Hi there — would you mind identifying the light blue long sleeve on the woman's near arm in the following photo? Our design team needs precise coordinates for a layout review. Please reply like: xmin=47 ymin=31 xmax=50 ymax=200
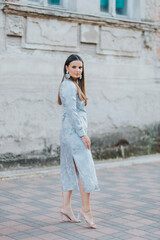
xmin=61 ymin=81 xmax=86 ymax=137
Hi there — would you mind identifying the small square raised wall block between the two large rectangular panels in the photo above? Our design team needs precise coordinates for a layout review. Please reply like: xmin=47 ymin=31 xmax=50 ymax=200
xmin=81 ymin=24 xmax=99 ymax=44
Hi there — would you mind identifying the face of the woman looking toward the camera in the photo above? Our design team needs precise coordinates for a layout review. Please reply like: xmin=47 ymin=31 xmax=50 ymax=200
xmin=66 ymin=60 xmax=83 ymax=80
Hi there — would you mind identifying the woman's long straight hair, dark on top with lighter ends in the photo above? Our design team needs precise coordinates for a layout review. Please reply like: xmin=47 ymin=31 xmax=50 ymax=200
xmin=58 ymin=54 xmax=88 ymax=106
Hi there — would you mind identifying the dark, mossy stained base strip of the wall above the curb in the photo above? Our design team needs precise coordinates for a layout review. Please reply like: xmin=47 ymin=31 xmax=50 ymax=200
xmin=0 ymin=124 xmax=160 ymax=171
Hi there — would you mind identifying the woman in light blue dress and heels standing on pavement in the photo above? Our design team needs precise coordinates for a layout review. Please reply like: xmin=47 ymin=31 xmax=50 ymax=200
xmin=58 ymin=55 xmax=100 ymax=228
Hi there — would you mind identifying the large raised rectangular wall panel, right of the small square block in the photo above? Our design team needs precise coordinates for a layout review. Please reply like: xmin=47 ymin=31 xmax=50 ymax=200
xmin=99 ymin=26 xmax=141 ymax=56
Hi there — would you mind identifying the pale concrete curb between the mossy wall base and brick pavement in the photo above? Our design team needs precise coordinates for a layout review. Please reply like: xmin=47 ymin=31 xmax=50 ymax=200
xmin=0 ymin=154 xmax=160 ymax=181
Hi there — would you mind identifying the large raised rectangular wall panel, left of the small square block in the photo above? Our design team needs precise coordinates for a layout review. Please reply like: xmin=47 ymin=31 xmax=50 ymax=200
xmin=26 ymin=17 xmax=78 ymax=48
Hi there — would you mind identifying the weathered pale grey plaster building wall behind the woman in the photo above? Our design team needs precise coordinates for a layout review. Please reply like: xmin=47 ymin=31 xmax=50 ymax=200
xmin=0 ymin=0 xmax=160 ymax=165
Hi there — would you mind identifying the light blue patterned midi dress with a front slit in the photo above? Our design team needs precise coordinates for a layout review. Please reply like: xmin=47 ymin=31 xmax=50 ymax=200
xmin=60 ymin=78 xmax=100 ymax=193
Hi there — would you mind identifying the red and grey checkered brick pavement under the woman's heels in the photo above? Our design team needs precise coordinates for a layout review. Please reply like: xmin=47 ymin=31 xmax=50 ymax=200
xmin=0 ymin=163 xmax=160 ymax=240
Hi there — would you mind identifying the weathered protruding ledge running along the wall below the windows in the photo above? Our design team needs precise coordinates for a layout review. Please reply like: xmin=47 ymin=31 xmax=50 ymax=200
xmin=0 ymin=2 xmax=160 ymax=32
